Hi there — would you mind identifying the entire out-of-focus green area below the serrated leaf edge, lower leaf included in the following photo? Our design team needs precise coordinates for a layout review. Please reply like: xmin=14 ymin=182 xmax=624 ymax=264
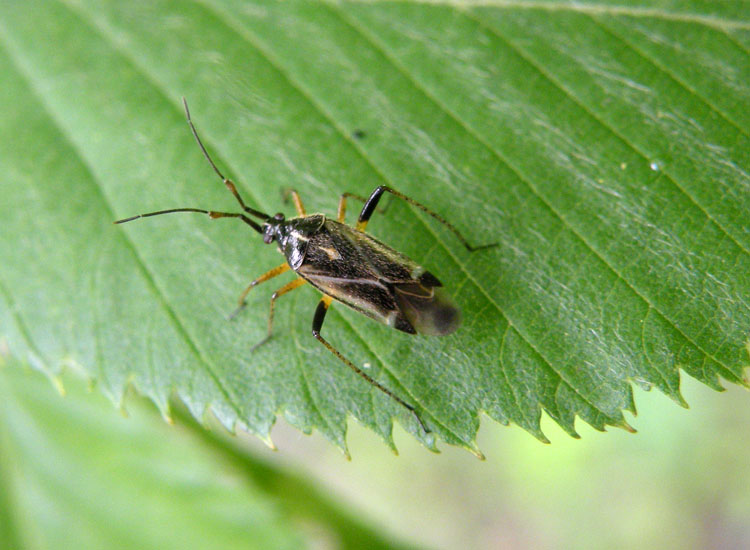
xmin=0 ymin=364 xmax=750 ymax=549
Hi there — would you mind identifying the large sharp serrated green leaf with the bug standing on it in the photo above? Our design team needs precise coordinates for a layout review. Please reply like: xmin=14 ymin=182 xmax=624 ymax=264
xmin=0 ymin=0 xmax=750 ymax=453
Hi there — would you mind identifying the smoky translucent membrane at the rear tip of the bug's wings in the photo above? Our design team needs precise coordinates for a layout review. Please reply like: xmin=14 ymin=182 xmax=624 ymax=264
xmin=393 ymin=282 xmax=461 ymax=336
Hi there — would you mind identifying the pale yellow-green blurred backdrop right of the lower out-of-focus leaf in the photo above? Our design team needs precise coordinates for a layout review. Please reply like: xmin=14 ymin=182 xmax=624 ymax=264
xmin=296 ymin=380 xmax=750 ymax=549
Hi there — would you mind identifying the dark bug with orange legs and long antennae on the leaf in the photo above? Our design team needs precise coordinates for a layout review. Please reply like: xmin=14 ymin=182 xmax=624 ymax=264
xmin=114 ymin=98 xmax=497 ymax=433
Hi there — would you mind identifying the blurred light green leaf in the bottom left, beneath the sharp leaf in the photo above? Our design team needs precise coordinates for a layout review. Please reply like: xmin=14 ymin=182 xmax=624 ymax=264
xmin=0 ymin=367 xmax=302 ymax=549
